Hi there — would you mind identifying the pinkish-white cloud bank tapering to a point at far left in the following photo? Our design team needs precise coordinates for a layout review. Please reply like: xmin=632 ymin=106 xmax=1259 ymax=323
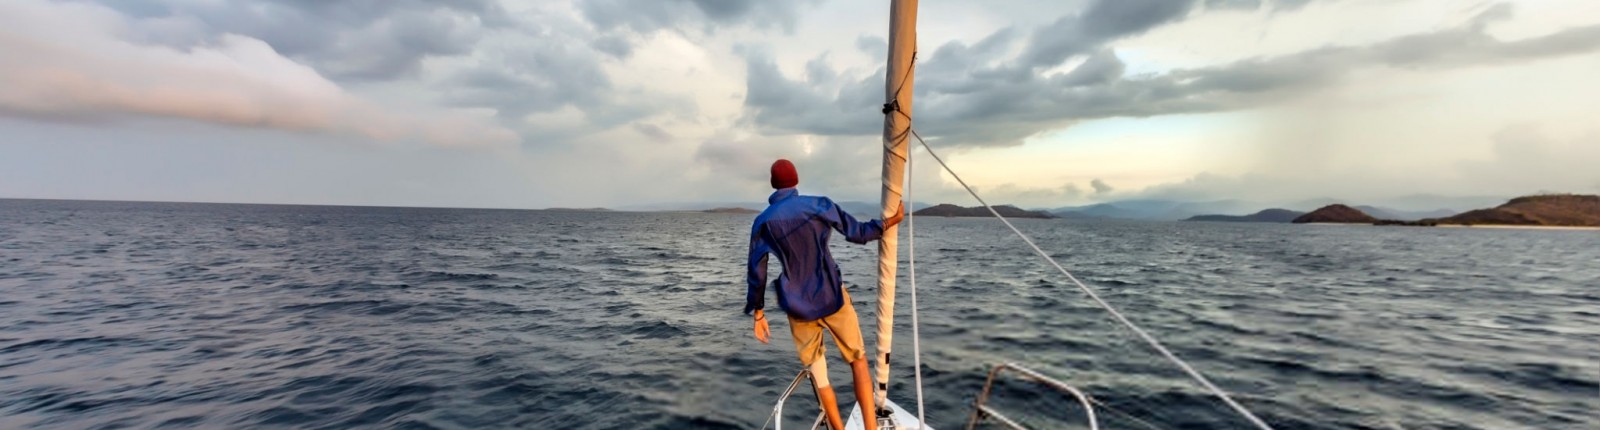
xmin=0 ymin=0 xmax=518 ymax=145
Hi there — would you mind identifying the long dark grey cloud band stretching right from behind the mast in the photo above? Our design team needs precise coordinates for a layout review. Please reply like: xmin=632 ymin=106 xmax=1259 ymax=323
xmin=732 ymin=6 xmax=1600 ymax=145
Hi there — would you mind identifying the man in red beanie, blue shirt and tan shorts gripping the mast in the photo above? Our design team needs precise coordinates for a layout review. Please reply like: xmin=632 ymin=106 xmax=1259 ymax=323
xmin=744 ymin=160 xmax=904 ymax=430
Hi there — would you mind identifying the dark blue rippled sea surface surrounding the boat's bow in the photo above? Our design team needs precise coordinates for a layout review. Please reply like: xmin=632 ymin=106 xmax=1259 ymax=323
xmin=0 ymin=200 xmax=1600 ymax=428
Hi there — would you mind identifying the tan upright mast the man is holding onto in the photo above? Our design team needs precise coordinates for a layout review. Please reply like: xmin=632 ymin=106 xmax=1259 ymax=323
xmin=862 ymin=0 xmax=917 ymax=406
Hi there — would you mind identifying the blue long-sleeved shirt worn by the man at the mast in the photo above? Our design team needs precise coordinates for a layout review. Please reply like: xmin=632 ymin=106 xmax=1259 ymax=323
xmin=744 ymin=189 xmax=883 ymax=321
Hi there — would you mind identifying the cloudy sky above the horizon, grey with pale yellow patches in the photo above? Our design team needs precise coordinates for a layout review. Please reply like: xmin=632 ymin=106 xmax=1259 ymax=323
xmin=0 ymin=0 xmax=1600 ymax=209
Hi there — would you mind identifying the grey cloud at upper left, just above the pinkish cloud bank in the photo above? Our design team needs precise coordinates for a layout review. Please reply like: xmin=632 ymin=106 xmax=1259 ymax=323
xmin=102 ymin=0 xmax=512 ymax=80
